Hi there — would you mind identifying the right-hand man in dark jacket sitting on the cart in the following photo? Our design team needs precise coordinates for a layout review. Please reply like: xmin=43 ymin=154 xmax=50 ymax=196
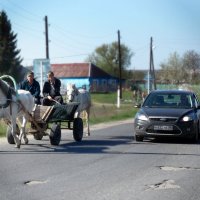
xmin=42 ymin=71 xmax=63 ymax=106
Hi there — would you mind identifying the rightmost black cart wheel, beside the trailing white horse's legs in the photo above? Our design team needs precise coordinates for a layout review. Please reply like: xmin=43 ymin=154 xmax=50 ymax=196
xmin=73 ymin=118 xmax=83 ymax=142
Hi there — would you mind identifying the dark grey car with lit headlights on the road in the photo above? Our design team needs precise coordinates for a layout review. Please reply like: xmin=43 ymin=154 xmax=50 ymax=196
xmin=134 ymin=90 xmax=200 ymax=141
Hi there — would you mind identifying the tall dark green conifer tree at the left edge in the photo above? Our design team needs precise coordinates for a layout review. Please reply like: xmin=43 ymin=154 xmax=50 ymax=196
xmin=0 ymin=11 xmax=22 ymax=81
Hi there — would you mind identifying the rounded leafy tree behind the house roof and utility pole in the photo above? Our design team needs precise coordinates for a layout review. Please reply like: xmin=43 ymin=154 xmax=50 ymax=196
xmin=86 ymin=42 xmax=133 ymax=78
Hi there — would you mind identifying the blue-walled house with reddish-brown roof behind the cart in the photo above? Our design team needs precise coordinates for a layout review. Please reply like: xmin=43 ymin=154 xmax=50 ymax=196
xmin=51 ymin=63 xmax=118 ymax=92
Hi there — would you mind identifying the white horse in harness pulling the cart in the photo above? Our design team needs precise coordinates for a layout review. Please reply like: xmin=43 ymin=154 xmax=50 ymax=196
xmin=0 ymin=79 xmax=34 ymax=148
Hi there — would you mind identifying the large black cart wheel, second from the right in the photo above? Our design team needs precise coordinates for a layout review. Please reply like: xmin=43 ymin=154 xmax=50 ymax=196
xmin=49 ymin=123 xmax=61 ymax=145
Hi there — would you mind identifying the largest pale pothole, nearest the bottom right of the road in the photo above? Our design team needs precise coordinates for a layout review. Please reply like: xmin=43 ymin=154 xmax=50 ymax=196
xmin=146 ymin=180 xmax=180 ymax=191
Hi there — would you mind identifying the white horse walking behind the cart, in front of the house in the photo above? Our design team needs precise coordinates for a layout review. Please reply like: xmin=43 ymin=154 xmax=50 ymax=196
xmin=67 ymin=84 xmax=91 ymax=136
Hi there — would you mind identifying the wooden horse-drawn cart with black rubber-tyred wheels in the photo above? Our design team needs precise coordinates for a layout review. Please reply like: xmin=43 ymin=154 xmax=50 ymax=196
xmin=7 ymin=102 xmax=83 ymax=145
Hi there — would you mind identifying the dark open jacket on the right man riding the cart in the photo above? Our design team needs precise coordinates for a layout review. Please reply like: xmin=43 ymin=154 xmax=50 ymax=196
xmin=42 ymin=77 xmax=61 ymax=98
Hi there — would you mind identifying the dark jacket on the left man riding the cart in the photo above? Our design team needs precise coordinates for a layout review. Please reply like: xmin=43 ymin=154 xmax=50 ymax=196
xmin=19 ymin=79 xmax=40 ymax=98
